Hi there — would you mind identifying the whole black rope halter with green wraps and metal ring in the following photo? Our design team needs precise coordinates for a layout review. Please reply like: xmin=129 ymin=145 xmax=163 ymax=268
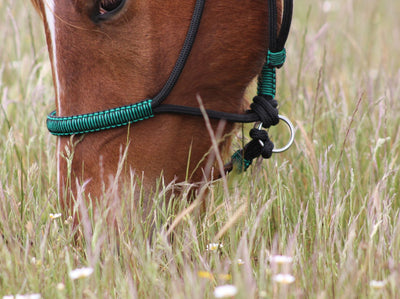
xmin=47 ymin=0 xmax=294 ymax=171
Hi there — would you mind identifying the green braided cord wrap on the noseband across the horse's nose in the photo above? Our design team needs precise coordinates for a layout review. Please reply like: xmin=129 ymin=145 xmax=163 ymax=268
xmin=47 ymin=100 xmax=154 ymax=136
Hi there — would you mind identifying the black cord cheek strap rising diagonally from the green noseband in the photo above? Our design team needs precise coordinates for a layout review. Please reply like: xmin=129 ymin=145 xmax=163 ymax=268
xmin=151 ymin=0 xmax=205 ymax=108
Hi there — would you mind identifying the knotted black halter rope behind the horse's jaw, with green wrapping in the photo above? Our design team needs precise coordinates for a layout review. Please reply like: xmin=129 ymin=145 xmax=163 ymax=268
xmin=225 ymin=0 xmax=293 ymax=172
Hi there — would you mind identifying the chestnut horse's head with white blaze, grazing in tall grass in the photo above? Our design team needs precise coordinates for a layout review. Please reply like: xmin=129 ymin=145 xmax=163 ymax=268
xmin=31 ymin=0 xmax=283 ymax=218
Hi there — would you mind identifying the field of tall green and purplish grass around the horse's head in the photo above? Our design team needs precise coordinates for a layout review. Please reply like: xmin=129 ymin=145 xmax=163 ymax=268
xmin=0 ymin=0 xmax=400 ymax=298
